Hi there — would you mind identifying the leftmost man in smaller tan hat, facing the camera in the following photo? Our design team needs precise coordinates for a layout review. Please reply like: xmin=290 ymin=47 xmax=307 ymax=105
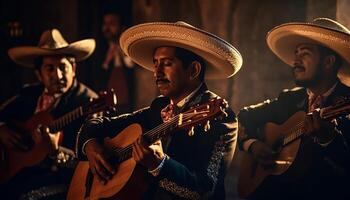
xmin=0 ymin=29 xmax=97 ymax=199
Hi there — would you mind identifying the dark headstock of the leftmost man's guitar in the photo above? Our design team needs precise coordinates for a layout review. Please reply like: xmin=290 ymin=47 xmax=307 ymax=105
xmin=84 ymin=89 xmax=117 ymax=115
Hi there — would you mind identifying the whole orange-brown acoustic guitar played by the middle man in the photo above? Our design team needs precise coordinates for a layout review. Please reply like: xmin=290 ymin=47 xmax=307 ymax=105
xmin=67 ymin=99 xmax=227 ymax=200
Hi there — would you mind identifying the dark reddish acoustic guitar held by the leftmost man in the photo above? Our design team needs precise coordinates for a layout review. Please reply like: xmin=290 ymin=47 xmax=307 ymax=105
xmin=0 ymin=90 xmax=117 ymax=183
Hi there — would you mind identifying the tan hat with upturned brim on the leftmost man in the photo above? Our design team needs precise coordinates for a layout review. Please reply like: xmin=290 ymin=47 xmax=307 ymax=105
xmin=8 ymin=29 xmax=96 ymax=68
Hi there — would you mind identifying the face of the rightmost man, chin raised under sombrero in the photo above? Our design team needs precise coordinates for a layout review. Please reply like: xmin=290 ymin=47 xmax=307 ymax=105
xmin=292 ymin=44 xmax=323 ymax=87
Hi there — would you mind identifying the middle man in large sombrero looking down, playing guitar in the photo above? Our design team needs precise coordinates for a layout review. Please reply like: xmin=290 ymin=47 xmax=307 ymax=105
xmin=78 ymin=22 xmax=242 ymax=199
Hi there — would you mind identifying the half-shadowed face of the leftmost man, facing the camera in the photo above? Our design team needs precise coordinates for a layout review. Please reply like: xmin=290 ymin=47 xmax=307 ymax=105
xmin=37 ymin=55 xmax=75 ymax=94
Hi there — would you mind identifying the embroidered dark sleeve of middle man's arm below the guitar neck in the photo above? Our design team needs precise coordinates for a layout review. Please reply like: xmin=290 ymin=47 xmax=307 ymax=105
xmin=157 ymin=106 xmax=237 ymax=199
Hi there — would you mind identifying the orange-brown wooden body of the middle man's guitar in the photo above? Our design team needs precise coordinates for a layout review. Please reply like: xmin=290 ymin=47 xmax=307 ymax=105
xmin=67 ymin=124 xmax=147 ymax=200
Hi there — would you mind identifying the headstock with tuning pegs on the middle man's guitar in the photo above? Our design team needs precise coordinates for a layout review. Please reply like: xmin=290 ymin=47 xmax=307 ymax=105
xmin=178 ymin=98 xmax=228 ymax=131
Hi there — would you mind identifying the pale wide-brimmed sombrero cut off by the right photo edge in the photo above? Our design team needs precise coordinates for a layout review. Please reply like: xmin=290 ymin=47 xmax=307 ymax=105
xmin=266 ymin=18 xmax=350 ymax=83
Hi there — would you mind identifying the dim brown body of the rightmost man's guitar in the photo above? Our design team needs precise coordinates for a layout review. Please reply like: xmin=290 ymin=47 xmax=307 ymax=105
xmin=238 ymin=111 xmax=312 ymax=198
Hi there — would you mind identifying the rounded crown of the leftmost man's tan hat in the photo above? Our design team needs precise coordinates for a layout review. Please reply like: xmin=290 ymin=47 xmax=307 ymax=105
xmin=38 ymin=29 xmax=68 ymax=50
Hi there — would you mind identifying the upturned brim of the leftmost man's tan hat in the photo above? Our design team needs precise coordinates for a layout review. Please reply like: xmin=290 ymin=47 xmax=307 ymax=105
xmin=8 ymin=39 xmax=96 ymax=68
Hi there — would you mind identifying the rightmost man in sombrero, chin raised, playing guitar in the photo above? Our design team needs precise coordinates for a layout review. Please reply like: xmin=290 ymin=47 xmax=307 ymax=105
xmin=238 ymin=18 xmax=350 ymax=199
